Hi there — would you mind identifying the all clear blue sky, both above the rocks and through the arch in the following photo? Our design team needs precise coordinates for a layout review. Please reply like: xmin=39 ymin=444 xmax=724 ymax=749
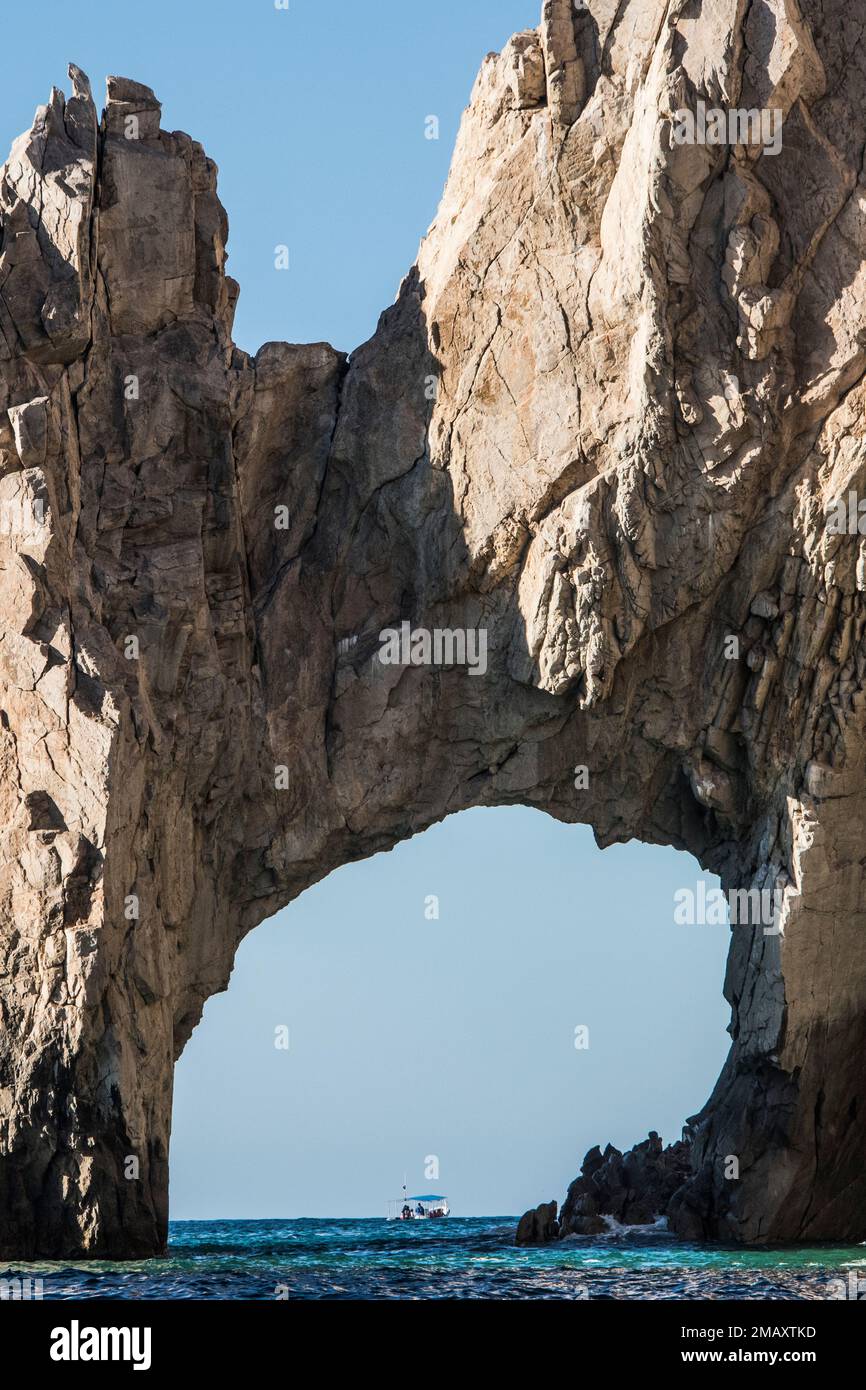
xmin=0 ymin=0 xmax=728 ymax=1218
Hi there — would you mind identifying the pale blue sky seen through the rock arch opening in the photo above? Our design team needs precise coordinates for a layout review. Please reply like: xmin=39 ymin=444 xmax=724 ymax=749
xmin=171 ymin=808 xmax=728 ymax=1219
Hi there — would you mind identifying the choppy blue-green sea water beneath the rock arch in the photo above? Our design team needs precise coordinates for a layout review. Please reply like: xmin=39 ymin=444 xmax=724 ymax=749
xmin=0 ymin=1216 xmax=866 ymax=1300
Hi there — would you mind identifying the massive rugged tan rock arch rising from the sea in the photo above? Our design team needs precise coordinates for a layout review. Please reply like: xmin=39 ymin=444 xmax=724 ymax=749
xmin=0 ymin=0 xmax=866 ymax=1258
